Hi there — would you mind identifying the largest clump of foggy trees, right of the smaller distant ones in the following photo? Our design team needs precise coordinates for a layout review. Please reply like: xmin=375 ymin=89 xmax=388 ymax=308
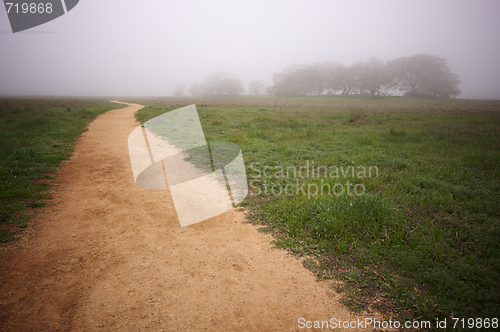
xmin=266 ymin=54 xmax=460 ymax=98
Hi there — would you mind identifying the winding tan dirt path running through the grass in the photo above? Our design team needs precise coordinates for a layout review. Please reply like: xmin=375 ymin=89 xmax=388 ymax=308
xmin=0 ymin=104 xmax=376 ymax=331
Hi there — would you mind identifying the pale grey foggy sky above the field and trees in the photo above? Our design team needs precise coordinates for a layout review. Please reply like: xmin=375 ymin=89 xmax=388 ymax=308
xmin=0 ymin=0 xmax=500 ymax=99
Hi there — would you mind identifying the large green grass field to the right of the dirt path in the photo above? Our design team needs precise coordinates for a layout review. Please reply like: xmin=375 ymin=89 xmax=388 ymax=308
xmin=134 ymin=97 xmax=500 ymax=319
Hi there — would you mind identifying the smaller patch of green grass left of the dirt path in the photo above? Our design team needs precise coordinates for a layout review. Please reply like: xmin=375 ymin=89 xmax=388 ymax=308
xmin=0 ymin=98 xmax=126 ymax=244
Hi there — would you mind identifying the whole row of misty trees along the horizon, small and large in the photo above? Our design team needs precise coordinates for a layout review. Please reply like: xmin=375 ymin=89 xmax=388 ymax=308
xmin=174 ymin=54 xmax=461 ymax=98
